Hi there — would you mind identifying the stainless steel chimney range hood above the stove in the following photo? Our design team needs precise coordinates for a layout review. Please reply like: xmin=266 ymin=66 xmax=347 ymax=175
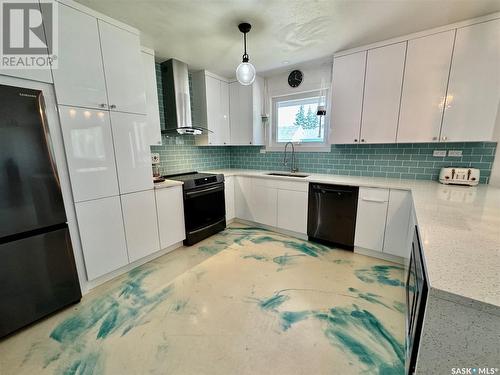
xmin=161 ymin=59 xmax=208 ymax=135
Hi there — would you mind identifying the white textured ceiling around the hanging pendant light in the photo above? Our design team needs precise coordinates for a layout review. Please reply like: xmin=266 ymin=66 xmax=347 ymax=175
xmin=77 ymin=0 xmax=500 ymax=78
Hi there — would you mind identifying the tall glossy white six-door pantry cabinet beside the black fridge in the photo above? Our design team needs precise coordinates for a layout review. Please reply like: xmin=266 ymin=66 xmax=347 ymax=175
xmin=53 ymin=4 xmax=165 ymax=280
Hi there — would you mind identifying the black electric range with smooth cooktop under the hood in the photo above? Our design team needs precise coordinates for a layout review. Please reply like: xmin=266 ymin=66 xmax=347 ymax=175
xmin=163 ymin=172 xmax=226 ymax=246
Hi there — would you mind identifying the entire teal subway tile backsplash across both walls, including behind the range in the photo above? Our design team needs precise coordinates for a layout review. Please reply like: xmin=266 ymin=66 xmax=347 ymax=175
xmin=151 ymin=64 xmax=497 ymax=183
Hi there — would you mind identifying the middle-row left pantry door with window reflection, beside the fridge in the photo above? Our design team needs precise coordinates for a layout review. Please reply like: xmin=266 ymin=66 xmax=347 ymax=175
xmin=59 ymin=106 xmax=118 ymax=202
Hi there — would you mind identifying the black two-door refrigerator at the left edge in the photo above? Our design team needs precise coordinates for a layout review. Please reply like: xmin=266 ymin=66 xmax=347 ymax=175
xmin=0 ymin=85 xmax=81 ymax=338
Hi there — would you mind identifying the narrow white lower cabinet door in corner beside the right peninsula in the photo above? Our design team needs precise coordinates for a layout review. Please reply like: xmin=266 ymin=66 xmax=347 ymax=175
xmin=383 ymin=189 xmax=413 ymax=258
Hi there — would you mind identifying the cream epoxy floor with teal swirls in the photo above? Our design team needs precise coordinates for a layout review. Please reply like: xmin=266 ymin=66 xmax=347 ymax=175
xmin=0 ymin=225 xmax=405 ymax=375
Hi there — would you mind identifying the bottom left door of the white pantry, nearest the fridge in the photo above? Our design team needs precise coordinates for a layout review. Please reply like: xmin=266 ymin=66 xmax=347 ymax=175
xmin=75 ymin=196 xmax=129 ymax=280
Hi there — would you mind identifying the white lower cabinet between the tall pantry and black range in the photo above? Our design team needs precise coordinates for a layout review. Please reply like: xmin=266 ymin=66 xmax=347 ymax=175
xmin=155 ymin=186 xmax=186 ymax=249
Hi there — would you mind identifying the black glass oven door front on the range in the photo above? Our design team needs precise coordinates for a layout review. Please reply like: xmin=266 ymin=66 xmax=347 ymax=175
xmin=184 ymin=185 xmax=226 ymax=232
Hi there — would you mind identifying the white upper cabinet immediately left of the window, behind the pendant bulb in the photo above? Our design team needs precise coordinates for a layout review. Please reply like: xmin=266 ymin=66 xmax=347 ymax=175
xmin=229 ymin=77 xmax=264 ymax=146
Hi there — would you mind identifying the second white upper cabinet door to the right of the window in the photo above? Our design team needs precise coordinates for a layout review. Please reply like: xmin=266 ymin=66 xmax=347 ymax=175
xmin=362 ymin=42 xmax=406 ymax=143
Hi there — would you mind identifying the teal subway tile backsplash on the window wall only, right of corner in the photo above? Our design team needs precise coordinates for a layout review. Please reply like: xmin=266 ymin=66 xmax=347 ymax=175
xmin=231 ymin=142 xmax=497 ymax=183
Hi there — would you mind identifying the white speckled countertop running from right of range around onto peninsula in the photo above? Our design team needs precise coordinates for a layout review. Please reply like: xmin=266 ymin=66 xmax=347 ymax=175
xmin=204 ymin=169 xmax=500 ymax=316
